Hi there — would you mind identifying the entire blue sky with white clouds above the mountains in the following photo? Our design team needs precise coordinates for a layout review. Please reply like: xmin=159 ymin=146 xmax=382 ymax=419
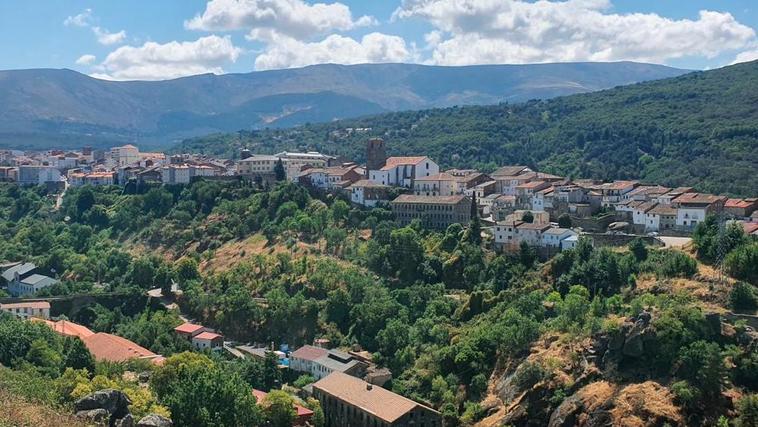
xmin=0 ymin=0 xmax=758 ymax=80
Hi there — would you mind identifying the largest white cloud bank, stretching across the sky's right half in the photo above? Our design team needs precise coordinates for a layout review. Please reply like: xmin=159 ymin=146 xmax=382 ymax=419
xmin=393 ymin=0 xmax=756 ymax=65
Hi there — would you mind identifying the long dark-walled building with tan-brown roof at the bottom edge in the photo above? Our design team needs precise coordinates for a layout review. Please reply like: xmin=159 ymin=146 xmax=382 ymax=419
xmin=313 ymin=372 xmax=442 ymax=427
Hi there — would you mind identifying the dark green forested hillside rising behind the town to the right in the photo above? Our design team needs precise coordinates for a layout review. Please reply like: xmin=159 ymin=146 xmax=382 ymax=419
xmin=177 ymin=62 xmax=758 ymax=196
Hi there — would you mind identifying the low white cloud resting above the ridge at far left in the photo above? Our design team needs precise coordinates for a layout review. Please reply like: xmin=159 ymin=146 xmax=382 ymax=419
xmin=92 ymin=35 xmax=242 ymax=80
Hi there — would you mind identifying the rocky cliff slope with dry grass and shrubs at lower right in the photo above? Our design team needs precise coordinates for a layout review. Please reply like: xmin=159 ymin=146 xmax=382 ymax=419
xmin=476 ymin=311 xmax=758 ymax=427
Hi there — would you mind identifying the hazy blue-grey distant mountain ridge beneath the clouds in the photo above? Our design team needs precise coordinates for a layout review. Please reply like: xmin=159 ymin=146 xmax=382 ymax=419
xmin=0 ymin=62 xmax=688 ymax=148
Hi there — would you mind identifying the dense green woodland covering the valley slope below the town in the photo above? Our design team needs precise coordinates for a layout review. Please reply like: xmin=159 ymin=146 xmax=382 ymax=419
xmin=0 ymin=181 xmax=758 ymax=426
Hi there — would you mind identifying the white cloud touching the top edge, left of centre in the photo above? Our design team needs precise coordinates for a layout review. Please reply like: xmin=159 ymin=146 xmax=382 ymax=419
xmin=184 ymin=0 xmax=377 ymax=40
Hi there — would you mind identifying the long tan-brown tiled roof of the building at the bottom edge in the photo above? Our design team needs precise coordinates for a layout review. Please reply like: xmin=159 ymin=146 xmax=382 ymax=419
xmin=313 ymin=372 xmax=436 ymax=423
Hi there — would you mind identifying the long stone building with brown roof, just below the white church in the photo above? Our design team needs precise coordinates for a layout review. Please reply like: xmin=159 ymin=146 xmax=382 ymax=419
xmin=390 ymin=194 xmax=471 ymax=230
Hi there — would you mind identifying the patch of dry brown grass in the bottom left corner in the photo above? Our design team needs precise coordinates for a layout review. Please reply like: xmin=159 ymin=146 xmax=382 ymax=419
xmin=0 ymin=389 xmax=89 ymax=427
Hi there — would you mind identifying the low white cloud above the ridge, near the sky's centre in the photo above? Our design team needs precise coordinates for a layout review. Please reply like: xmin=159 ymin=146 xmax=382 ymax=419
xmin=255 ymin=33 xmax=412 ymax=70
